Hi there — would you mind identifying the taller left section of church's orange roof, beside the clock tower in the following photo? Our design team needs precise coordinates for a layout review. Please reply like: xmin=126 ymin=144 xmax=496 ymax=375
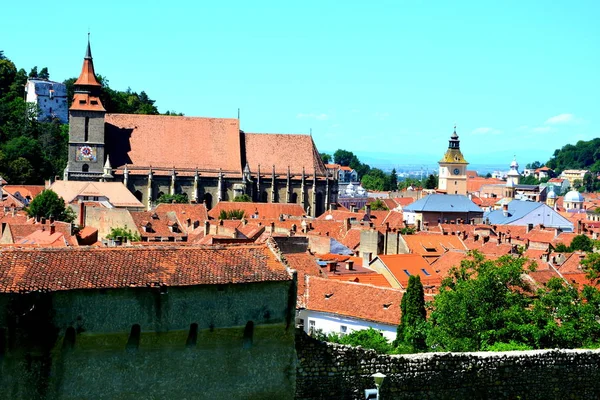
xmin=105 ymin=114 xmax=243 ymax=174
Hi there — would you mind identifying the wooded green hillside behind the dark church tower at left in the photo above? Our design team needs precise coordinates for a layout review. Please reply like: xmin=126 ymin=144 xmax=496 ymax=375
xmin=0 ymin=50 xmax=182 ymax=184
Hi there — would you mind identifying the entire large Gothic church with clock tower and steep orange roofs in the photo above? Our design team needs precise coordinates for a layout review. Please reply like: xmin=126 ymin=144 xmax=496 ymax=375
xmin=64 ymin=42 xmax=337 ymax=216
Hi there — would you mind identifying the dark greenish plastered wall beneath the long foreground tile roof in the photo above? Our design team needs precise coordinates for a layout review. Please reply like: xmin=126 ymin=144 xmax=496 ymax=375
xmin=0 ymin=281 xmax=296 ymax=399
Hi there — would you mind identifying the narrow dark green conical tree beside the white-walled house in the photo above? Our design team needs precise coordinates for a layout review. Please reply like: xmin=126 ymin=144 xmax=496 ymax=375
xmin=395 ymin=275 xmax=427 ymax=351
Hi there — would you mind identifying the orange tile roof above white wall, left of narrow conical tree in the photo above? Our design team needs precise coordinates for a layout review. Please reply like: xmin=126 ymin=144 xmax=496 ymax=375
xmin=306 ymin=276 xmax=404 ymax=325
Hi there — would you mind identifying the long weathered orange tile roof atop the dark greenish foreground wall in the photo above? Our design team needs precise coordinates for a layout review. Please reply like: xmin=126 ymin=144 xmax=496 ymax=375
xmin=0 ymin=242 xmax=291 ymax=293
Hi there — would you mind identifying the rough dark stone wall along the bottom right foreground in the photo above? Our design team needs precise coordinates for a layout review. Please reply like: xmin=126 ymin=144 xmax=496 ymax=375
xmin=296 ymin=334 xmax=600 ymax=400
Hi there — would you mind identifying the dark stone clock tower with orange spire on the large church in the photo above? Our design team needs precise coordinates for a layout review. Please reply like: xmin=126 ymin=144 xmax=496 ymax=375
xmin=64 ymin=34 xmax=106 ymax=180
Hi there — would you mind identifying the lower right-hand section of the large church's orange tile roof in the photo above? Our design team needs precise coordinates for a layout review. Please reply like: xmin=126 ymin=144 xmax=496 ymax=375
xmin=245 ymin=133 xmax=325 ymax=176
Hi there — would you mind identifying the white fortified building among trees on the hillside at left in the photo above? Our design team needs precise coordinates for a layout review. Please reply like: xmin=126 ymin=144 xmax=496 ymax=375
xmin=25 ymin=79 xmax=69 ymax=124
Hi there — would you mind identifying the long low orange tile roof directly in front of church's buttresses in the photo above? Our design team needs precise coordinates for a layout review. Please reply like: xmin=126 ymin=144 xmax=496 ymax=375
xmin=208 ymin=201 xmax=306 ymax=220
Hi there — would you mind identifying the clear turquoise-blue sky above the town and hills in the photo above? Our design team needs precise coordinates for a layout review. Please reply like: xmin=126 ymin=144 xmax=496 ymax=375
xmin=0 ymin=0 xmax=600 ymax=166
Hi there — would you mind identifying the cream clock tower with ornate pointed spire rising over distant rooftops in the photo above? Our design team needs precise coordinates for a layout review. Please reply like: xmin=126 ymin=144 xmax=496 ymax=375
xmin=438 ymin=126 xmax=469 ymax=195
